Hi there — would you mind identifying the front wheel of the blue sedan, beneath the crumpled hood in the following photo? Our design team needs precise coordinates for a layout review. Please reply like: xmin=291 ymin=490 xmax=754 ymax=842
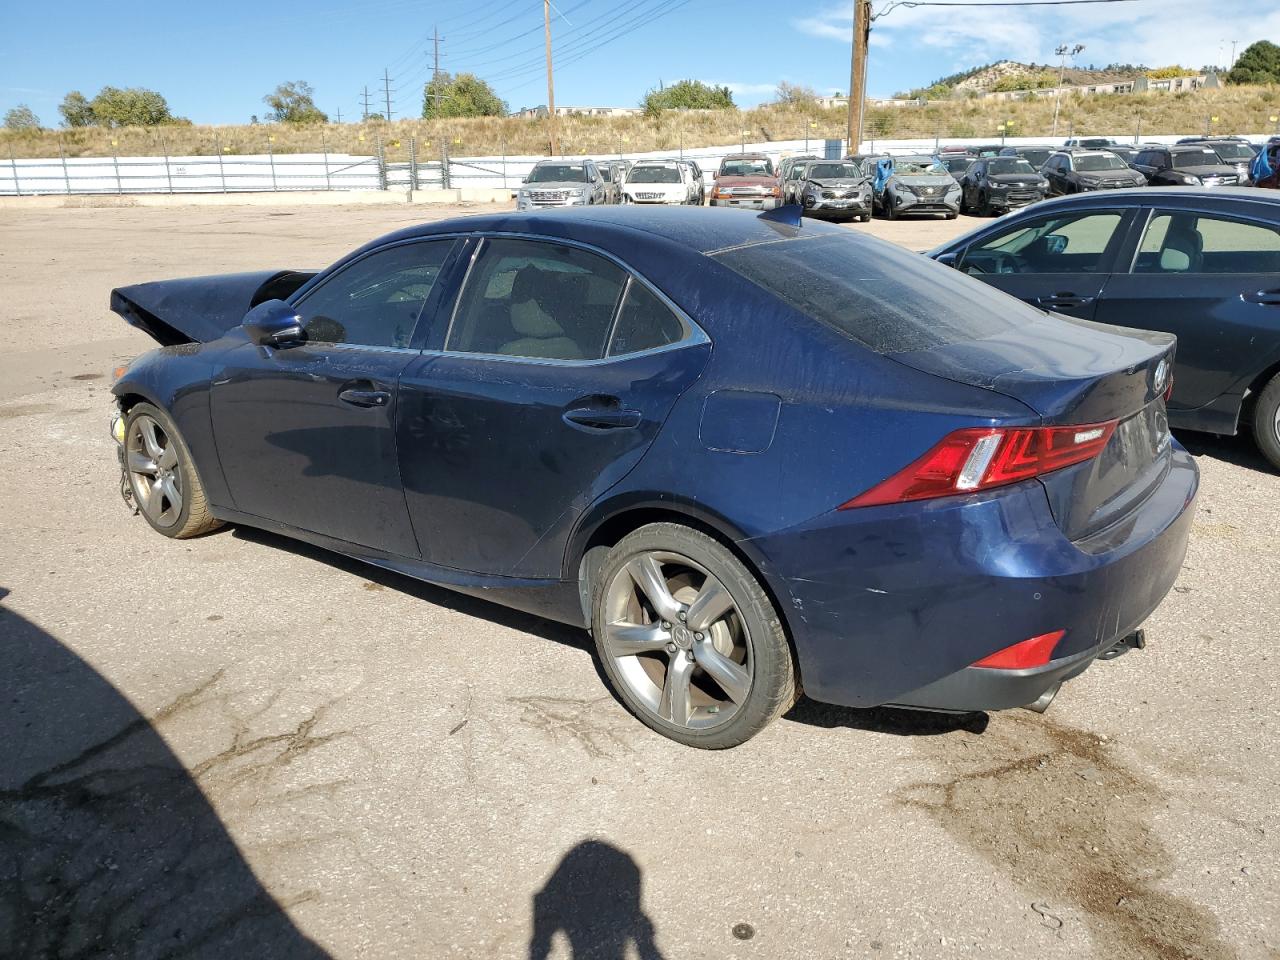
xmin=124 ymin=403 xmax=221 ymax=540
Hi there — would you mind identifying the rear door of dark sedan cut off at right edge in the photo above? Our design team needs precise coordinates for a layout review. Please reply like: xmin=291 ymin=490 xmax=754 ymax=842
xmin=1097 ymin=207 xmax=1280 ymax=417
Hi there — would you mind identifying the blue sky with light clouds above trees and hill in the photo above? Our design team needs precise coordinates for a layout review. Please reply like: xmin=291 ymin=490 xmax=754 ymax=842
xmin=0 ymin=0 xmax=1280 ymax=125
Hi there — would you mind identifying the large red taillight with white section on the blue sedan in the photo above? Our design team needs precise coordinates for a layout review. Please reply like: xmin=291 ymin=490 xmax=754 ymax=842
xmin=840 ymin=420 xmax=1119 ymax=509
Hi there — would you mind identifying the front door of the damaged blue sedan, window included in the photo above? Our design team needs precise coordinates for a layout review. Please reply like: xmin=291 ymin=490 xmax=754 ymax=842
xmin=210 ymin=239 xmax=454 ymax=557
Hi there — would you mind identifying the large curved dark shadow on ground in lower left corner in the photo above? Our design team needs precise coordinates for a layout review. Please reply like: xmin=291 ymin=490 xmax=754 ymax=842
xmin=0 ymin=588 xmax=328 ymax=960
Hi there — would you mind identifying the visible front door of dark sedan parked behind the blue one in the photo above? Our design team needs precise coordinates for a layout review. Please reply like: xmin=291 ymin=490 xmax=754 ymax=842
xmin=956 ymin=207 xmax=1133 ymax=320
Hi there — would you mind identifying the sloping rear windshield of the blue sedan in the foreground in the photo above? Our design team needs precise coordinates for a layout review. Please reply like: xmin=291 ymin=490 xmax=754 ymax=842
xmin=710 ymin=234 xmax=1018 ymax=353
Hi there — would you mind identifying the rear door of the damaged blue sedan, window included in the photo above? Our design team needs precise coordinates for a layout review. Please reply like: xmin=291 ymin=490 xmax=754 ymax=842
xmin=398 ymin=237 xmax=709 ymax=579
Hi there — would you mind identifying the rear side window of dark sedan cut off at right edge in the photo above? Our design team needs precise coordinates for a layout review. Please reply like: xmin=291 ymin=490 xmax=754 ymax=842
xmin=1133 ymin=214 xmax=1280 ymax=274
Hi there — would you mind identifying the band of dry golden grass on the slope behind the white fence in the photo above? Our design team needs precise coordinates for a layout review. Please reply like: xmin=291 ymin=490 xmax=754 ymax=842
xmin=0 ymin=86 xmax=1280 ymax=160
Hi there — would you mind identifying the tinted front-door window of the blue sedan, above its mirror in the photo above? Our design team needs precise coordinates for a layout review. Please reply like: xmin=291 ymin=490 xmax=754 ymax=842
xmin=298 ymin=239 xmax=454 ymax=347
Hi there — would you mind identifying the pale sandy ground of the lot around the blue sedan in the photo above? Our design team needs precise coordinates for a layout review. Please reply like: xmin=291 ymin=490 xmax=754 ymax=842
xmin=0 ymin=207 xmax=1280 ymax=960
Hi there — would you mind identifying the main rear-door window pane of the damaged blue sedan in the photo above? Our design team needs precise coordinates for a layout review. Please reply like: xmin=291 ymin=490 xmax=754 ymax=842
xmin=445 ymin=238 xmax=626 ymax=360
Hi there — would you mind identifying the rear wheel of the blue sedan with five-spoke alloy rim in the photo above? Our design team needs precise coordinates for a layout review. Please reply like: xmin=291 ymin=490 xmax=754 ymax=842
xmin=591 ymin=524 xmax=799 ymax=750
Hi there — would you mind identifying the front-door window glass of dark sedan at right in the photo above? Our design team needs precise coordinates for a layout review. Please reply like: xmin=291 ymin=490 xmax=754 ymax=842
xmin=959 ymin=210 xmax=1123 ymax=274
